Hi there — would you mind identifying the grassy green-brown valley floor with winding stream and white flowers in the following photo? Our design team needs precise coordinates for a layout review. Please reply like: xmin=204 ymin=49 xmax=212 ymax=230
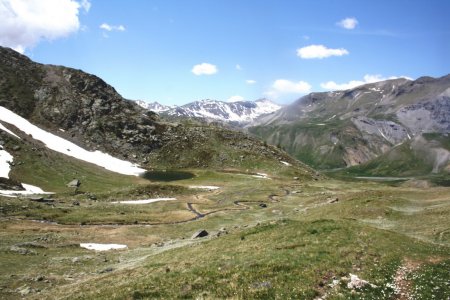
xmin=0 ymin=170 xmax=450 ymax=299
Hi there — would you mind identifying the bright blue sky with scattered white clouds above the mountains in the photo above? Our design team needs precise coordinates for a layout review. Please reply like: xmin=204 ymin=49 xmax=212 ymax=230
xmin=0 ymin=0 xmax=450 ymax=105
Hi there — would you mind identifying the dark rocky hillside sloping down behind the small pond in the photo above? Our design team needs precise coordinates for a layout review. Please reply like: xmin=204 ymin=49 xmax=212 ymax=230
xmin=0 ymin=47 xmax=312 ymax=180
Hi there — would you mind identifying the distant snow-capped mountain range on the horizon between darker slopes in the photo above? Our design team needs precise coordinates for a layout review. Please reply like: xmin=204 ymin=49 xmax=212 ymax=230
xmin=137 ymin=99 xmax=281 ymax=124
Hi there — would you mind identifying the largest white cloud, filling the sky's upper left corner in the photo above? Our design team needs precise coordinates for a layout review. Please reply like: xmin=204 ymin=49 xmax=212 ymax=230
xmin=0 ymin=0 xmax=90 ymax=53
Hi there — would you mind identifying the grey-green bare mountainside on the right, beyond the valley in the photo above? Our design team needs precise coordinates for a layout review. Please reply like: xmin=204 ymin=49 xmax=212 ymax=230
xmin=249 ymin=75 xmax=450 ymax=172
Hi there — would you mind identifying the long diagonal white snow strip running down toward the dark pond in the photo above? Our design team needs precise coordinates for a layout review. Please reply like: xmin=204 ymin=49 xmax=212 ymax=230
xmin=0 ymin=106 xmax=145 ymax=176
